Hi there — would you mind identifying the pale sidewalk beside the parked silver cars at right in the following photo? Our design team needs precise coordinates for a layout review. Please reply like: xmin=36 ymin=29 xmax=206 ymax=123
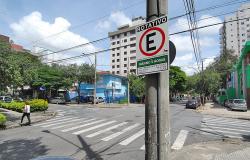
xmin=197 ymin=102 xmax=250 ymax=120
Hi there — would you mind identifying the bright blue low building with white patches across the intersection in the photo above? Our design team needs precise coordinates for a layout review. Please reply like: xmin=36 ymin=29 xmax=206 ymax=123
xmin=68 ymin=72 xmax=128 ymax=102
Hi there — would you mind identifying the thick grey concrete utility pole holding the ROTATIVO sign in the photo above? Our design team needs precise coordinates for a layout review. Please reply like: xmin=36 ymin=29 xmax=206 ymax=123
xmin=145 ymin=0 xmax=170 ymax=160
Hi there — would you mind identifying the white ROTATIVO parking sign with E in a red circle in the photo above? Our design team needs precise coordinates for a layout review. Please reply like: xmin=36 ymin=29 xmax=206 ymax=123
xmin=136 ymin=16 xmax=169 ymax=75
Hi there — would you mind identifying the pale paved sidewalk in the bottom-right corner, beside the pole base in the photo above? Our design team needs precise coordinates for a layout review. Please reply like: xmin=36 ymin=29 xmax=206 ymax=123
xmin=170 ymin=140 xmax=250 ymax=160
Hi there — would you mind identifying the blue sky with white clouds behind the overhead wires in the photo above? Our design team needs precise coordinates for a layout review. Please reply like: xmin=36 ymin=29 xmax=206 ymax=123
xmin=0 ymin=0 xmax=246 ymax=75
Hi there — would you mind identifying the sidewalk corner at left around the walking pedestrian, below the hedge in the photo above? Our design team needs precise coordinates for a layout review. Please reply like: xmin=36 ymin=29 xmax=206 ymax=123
xmin=0 ymin=108 xmax=56 ymax=130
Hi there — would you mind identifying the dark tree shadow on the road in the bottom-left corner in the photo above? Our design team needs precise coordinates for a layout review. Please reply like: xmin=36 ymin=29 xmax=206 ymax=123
xmin=0 ymin=138 xmax=49 ymax=160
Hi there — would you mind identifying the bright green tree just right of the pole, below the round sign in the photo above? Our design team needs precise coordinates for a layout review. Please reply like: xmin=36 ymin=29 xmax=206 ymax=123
xmin=169 ymin=66 xmax=187 ymax=96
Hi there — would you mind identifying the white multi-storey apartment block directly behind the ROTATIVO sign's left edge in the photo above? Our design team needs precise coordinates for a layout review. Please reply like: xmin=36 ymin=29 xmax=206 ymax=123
xmin=109 ymin=17 xmax=145 ymax=76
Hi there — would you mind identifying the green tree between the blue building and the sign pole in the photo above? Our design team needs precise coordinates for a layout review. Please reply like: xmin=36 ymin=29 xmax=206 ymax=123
xmin=128 ymin=74 xmax=145 ymax=97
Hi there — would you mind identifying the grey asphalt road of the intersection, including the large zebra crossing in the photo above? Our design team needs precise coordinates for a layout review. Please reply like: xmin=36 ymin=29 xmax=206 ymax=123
xmin=0 ymin=104 xmax=236 ymax=160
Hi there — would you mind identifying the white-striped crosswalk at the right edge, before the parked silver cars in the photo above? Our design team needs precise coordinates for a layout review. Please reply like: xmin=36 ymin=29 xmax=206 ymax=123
xmin=201 ymin=116 xmax=250 ymax=139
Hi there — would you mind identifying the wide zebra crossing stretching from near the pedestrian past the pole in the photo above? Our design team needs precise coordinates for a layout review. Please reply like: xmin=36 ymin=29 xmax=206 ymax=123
xmin=33 ymin=110 xmax=188 ymax=151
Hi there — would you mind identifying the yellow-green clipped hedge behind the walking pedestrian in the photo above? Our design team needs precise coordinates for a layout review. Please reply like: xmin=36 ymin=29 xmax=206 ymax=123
xmin=0 ymin=99 xmax=48 ymax=113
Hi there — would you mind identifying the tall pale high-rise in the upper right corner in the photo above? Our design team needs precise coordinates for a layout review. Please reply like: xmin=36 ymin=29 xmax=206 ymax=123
xmin=220 ymin=3 xmax=250 ymax=56
